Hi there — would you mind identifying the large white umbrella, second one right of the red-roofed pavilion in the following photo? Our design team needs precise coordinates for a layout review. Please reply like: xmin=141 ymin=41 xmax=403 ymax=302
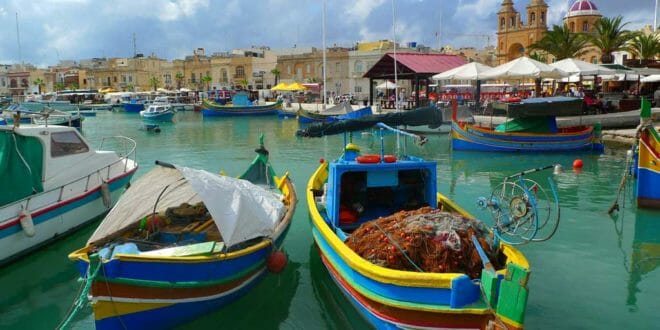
xmin=482 ymin=56 xmax=568 ymax=79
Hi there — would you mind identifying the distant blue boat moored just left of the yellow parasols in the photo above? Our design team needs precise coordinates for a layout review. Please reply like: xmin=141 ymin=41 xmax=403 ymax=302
xmin=202 ymin=92 xmax=282 ymax=116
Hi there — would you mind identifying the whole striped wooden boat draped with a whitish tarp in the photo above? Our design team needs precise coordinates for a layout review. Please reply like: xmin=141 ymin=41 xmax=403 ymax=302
xmin=69 ymin=136 xmax=297 ymax=329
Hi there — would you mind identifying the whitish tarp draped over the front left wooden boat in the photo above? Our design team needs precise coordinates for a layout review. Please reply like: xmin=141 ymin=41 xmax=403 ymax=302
xmin=87 ymin=166 xmax=286 ymax=247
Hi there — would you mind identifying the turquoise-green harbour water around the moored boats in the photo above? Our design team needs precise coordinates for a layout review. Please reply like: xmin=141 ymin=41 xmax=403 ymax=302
xmin=0 ymin=112 xmax=660 ymax=329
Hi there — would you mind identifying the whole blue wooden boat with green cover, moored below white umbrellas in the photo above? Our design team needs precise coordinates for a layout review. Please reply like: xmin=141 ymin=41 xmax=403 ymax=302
xmin=451 ymin=100 xmax=604 ymax=152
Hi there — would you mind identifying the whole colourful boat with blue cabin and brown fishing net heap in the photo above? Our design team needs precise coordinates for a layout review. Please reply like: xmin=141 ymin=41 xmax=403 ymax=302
xmin=306 ymin=124 xmax=530 ymax=329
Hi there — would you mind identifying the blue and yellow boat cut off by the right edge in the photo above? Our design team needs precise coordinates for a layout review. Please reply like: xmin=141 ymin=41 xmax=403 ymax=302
xmin=637 ymin=100 xmax=660 ymax=209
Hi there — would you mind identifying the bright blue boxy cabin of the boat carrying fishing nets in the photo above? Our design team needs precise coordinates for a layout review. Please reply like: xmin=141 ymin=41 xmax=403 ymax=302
xmin=326 ymin=146 xmax=437 ymax=231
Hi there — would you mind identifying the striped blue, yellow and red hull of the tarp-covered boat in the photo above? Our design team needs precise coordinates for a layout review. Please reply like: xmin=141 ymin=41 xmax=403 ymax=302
xmin=69 ymin=177 xmax=297 ymax=329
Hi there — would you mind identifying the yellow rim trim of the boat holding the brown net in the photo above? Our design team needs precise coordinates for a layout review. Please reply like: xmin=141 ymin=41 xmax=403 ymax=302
xmin=306 ymin=162 xmax=529 ymax=288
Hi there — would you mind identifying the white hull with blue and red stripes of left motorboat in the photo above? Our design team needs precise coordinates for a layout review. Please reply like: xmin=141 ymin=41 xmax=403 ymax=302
xmin=0 ymin=167 xmax=137 ymax=264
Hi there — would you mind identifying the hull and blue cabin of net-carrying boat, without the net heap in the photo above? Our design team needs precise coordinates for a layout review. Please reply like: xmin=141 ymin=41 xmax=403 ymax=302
xmin=306 ymin=127 xmax=529 ymax=329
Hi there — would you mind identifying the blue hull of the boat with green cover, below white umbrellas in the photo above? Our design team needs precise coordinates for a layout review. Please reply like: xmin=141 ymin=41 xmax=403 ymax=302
xmin=451 ymin=122 xmax=603 ymax=152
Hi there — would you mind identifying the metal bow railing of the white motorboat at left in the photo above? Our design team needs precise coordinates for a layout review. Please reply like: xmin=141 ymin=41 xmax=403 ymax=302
xmin=0 ymin=136 xmax=137 ymax=214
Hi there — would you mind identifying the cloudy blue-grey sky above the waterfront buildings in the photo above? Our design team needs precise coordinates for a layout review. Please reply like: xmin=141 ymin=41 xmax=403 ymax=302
xmin=0 ymin=0 xmax=655 ymax=67
